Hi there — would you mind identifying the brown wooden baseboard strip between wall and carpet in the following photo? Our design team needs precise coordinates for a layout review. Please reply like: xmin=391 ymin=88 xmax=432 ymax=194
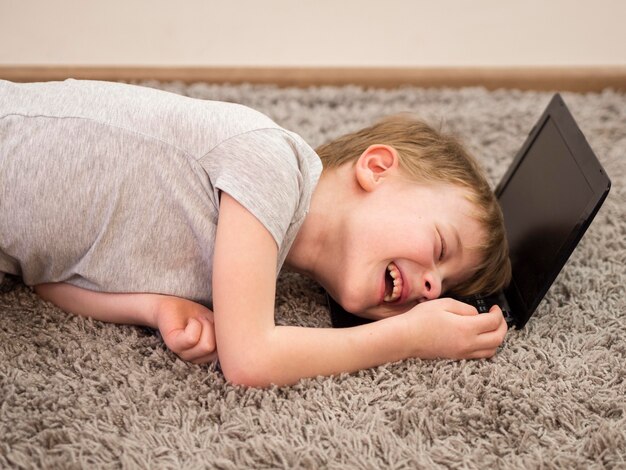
xmin=0 ymin=66 xmax=626 ymax=92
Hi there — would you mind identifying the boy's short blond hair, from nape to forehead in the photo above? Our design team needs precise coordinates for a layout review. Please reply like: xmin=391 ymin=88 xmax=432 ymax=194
xmin=317 ymin=114 xmax=511 ymax=296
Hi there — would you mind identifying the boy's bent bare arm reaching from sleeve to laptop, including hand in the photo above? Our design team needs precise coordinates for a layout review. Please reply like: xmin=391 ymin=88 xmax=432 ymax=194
xmin=213 ymin=193 xmax=506 ymax=386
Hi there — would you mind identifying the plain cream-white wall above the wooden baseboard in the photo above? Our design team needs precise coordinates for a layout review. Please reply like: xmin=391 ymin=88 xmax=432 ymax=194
xmin=0 ymin=0 xmax=626 ymax=67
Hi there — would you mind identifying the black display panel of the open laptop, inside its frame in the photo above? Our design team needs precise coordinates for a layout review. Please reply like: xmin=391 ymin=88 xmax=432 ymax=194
xmin=499 ymin=118 xmax=594 ymax=308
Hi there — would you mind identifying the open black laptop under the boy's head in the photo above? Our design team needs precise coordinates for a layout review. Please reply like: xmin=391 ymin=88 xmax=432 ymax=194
xmin=328 ymin=94 xmax=611 ymax=328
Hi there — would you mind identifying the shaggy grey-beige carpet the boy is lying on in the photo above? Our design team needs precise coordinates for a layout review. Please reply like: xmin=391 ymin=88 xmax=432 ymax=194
xmin=0 ymin=83 xmax=626 ymax=469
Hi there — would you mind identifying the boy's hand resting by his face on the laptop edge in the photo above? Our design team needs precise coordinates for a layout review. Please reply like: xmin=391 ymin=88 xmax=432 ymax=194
xmin=406 ymin=299 xmax=508 ymax=359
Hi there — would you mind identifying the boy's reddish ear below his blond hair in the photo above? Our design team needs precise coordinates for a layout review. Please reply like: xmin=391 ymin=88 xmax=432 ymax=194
xmin=354 ymin=144 xmax=399 ymax=192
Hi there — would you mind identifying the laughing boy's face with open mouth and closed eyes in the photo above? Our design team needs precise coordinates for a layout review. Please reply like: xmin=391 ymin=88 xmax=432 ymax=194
xmin=331 ymin=179 xmax=483 ymax=319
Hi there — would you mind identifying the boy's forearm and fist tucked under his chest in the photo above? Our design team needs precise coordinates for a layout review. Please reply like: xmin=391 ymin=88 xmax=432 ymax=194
xmin=34 ymin=283 xmax=217 ymax=363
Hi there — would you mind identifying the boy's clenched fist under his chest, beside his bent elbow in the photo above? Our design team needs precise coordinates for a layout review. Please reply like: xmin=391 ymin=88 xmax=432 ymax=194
xmin=155 ymin=295 xmax=217 ymax=364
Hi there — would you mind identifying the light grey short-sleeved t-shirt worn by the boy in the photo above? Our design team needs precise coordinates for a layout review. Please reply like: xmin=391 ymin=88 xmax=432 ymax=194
xmin=0 ymin=80 xmax=322 ymax=307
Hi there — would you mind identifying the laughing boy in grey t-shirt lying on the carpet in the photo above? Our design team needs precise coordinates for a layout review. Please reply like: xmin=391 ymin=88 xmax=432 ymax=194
xmin=0 ymin=80 xmax=509 ymax=386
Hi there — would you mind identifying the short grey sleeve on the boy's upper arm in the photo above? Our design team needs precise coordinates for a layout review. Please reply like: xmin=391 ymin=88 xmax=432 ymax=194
xmin=199 ymin=128 xmax=303 ymax=249
